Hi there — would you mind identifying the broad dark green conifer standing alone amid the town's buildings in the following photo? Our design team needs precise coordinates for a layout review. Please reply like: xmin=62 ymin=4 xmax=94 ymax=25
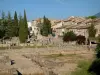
xmin=40 ymin=16 xmax=52 ymax=36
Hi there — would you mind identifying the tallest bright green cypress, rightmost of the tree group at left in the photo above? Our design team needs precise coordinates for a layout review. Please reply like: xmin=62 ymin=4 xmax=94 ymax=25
xmin=19 ymin=10 xmax=28 ymax=43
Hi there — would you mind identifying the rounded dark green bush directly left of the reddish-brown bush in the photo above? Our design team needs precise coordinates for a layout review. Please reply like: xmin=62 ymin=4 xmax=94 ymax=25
xmin=63 ymin=31 xmax=76 ymax=42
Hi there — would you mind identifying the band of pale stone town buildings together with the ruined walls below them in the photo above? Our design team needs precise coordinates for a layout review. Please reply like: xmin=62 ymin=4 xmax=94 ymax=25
xmin=0 ymin=16 xmax=100 ymax=47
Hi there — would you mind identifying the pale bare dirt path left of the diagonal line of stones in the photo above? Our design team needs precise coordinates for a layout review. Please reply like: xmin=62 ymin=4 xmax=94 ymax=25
xmin=9 ymin=52 xmax=43 ymax=75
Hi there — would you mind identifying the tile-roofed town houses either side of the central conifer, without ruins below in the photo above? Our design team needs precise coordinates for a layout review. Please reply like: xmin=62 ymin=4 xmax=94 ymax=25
xmin=25 ymin=16 xmax=100 ymax=45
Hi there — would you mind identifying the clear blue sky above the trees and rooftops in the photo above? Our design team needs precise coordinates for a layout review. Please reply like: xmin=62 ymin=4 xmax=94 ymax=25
xmin=0 ymin=0 xmax=100 ymax=21
